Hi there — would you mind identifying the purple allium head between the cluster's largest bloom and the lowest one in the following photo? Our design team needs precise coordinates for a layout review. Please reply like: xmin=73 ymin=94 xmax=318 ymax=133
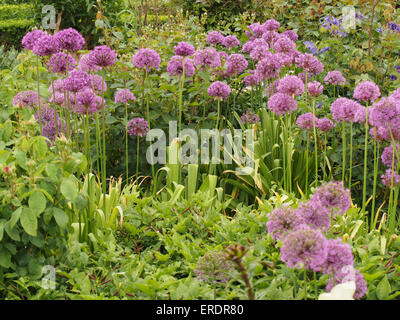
xmin=323 ymin=239 xmax=354 ymax=273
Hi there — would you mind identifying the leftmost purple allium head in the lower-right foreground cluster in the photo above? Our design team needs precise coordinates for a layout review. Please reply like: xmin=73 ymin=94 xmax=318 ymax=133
xmin=267 ymin=206 xmax=303 ymax=240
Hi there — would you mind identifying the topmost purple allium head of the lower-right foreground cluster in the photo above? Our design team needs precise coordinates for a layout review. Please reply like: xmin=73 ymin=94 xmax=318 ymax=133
xmin=311 ymin=181 xmax=351 ymax=216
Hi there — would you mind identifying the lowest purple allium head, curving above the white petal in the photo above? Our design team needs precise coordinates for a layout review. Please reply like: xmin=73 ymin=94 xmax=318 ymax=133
xmin=326 ymin=265 xmax=368 ymax=300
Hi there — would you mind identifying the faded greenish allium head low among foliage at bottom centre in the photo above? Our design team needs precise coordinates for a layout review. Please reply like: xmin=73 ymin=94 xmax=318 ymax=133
xmin=194 ymin=251 xmax=234 ymax=284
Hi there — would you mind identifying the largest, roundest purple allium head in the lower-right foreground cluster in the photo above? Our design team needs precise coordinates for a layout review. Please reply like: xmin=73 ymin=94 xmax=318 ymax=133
xmin=281 ymin=224 xmax=328 ymax=271
